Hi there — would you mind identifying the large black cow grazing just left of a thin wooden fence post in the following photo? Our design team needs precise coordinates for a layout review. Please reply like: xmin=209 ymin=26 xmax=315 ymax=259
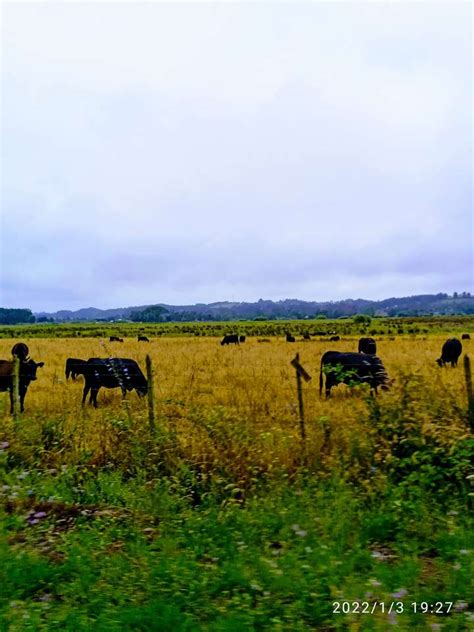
xmin=82 ymin=358 xmax=148 ymax=408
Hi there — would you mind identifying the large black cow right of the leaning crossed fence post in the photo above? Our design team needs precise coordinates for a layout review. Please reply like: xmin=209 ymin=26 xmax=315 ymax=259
xmin=319 ymin=351 xmax=391 ymax=397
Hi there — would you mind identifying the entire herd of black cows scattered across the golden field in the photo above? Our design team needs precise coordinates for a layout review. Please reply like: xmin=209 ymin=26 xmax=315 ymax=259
xmin=0 ymin=333 xmax=470 ymax=412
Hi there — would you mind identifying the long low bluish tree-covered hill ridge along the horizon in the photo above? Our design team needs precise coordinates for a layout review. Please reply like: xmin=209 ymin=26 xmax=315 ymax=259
xmin=30 ymin=292 xmax=474 ymax=322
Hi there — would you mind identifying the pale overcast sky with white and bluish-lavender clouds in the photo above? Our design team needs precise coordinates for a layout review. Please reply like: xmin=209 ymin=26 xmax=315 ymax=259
xmin=0 ymin=2 xmax=473 ymax=311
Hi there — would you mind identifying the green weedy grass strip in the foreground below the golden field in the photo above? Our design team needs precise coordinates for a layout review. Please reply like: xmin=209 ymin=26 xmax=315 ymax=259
xmin=0 ymin=463 xmax=474 ymax=632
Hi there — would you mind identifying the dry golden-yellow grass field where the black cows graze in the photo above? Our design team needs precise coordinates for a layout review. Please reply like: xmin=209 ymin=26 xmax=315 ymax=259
xmin=0 ymin=335 xmax=472 ymax=480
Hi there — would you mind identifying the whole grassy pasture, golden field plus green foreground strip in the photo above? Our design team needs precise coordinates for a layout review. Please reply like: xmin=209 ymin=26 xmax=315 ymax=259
xmin=0 ymin=320 xmax=474 ymax=631
